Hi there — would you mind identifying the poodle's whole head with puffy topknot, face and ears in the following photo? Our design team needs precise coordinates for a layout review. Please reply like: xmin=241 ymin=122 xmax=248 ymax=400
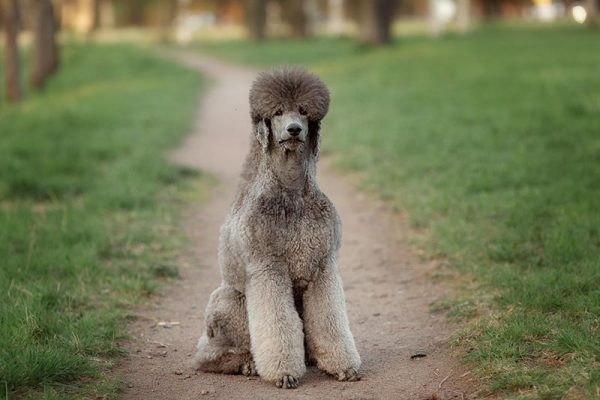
xmin=250 ymin=68 xmax=329 ymax=155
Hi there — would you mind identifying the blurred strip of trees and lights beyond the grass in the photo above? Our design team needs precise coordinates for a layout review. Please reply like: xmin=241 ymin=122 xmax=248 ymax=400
xmin=2 ymin=0 xmax=598 ymax=100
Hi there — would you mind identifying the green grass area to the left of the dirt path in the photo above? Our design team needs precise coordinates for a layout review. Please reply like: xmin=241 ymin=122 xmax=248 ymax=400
xmin=0 ymin=43 xmax=205 ymax=399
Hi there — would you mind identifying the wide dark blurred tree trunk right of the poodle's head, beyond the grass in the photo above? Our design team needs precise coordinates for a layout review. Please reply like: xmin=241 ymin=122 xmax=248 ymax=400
xmin=359 ymin=0 xmax=396 ymax=45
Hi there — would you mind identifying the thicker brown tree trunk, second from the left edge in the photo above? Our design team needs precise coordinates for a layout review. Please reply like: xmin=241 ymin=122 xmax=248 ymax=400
xmin=31 ymin=0 xmax=58 ymax=88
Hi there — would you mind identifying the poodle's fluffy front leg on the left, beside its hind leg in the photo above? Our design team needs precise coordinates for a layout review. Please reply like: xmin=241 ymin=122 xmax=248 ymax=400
xmin=246 ymin=264 xmax=306 ymax=388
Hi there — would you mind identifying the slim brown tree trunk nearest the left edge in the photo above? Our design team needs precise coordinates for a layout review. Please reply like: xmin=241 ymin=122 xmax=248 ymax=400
xmin=0 ymin=0 xmax=23 ymax=102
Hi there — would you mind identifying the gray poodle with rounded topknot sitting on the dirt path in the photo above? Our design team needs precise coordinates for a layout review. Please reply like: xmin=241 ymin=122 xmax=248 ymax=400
xmin=194 ymin=68 xmax=361 ymax=388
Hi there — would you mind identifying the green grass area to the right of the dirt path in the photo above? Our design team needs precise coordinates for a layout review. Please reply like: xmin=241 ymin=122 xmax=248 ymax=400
xmin=193 ymin=26 xmax=600 ymax=399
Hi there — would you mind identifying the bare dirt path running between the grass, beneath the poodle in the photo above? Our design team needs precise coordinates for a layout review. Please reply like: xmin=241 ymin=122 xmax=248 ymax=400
xmin=121 ymin=53 xmax=468 ymax=400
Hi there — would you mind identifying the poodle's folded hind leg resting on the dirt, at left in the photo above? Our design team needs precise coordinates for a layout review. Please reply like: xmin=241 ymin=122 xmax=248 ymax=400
xmin=194 ymin=286 xmax=256 ymax=375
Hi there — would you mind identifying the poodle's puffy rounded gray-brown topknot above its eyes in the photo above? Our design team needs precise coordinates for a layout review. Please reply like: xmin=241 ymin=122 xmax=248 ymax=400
xmin=250 ymin=67 xmax=329 ymax=123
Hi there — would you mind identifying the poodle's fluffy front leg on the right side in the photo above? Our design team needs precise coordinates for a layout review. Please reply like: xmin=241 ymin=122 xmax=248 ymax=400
xmin=303 ymin=259 xmax=360 ymax=381
